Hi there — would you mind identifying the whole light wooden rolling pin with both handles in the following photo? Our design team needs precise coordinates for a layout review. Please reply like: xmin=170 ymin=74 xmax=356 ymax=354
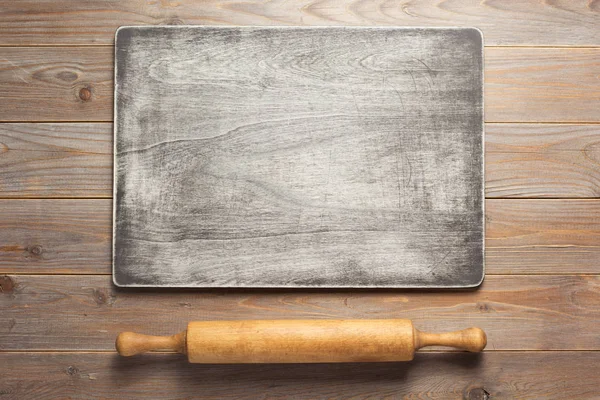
xmin=116 ymin=319 xmax=487 ymax=364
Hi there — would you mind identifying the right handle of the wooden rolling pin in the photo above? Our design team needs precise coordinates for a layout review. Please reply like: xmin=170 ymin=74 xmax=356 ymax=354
xmin=414 ymin=328 xmax=487 ymax=352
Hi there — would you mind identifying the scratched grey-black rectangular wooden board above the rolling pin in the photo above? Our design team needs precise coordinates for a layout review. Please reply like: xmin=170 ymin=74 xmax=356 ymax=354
xmin=113 ymin=26 xmax=484 ymax=288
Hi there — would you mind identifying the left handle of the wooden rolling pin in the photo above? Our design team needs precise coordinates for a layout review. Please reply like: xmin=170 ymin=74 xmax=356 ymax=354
xmin=115 ymin=331 xmax=186 ymax=357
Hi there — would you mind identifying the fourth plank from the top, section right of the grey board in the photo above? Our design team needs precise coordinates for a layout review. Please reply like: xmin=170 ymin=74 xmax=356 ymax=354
xmin=486 ymin=199 xmax=600 ymax=274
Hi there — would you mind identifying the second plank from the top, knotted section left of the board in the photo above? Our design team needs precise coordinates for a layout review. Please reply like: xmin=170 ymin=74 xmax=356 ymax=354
xmin=0 ymin=47 xmax=113 ymax=121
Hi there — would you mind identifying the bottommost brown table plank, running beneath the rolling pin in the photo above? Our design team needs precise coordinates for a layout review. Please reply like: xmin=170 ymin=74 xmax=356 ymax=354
xmin=0 ymin=351 xmax=600 ymax=400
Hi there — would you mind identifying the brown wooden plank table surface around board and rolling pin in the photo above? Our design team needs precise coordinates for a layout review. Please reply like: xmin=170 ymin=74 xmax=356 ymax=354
xmin=0 ymin=0 xmax=600 ymax=399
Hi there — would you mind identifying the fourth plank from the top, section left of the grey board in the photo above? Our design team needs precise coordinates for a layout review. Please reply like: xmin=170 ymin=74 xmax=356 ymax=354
xmin=0 ymin=199 xmax=112 ymax=274
